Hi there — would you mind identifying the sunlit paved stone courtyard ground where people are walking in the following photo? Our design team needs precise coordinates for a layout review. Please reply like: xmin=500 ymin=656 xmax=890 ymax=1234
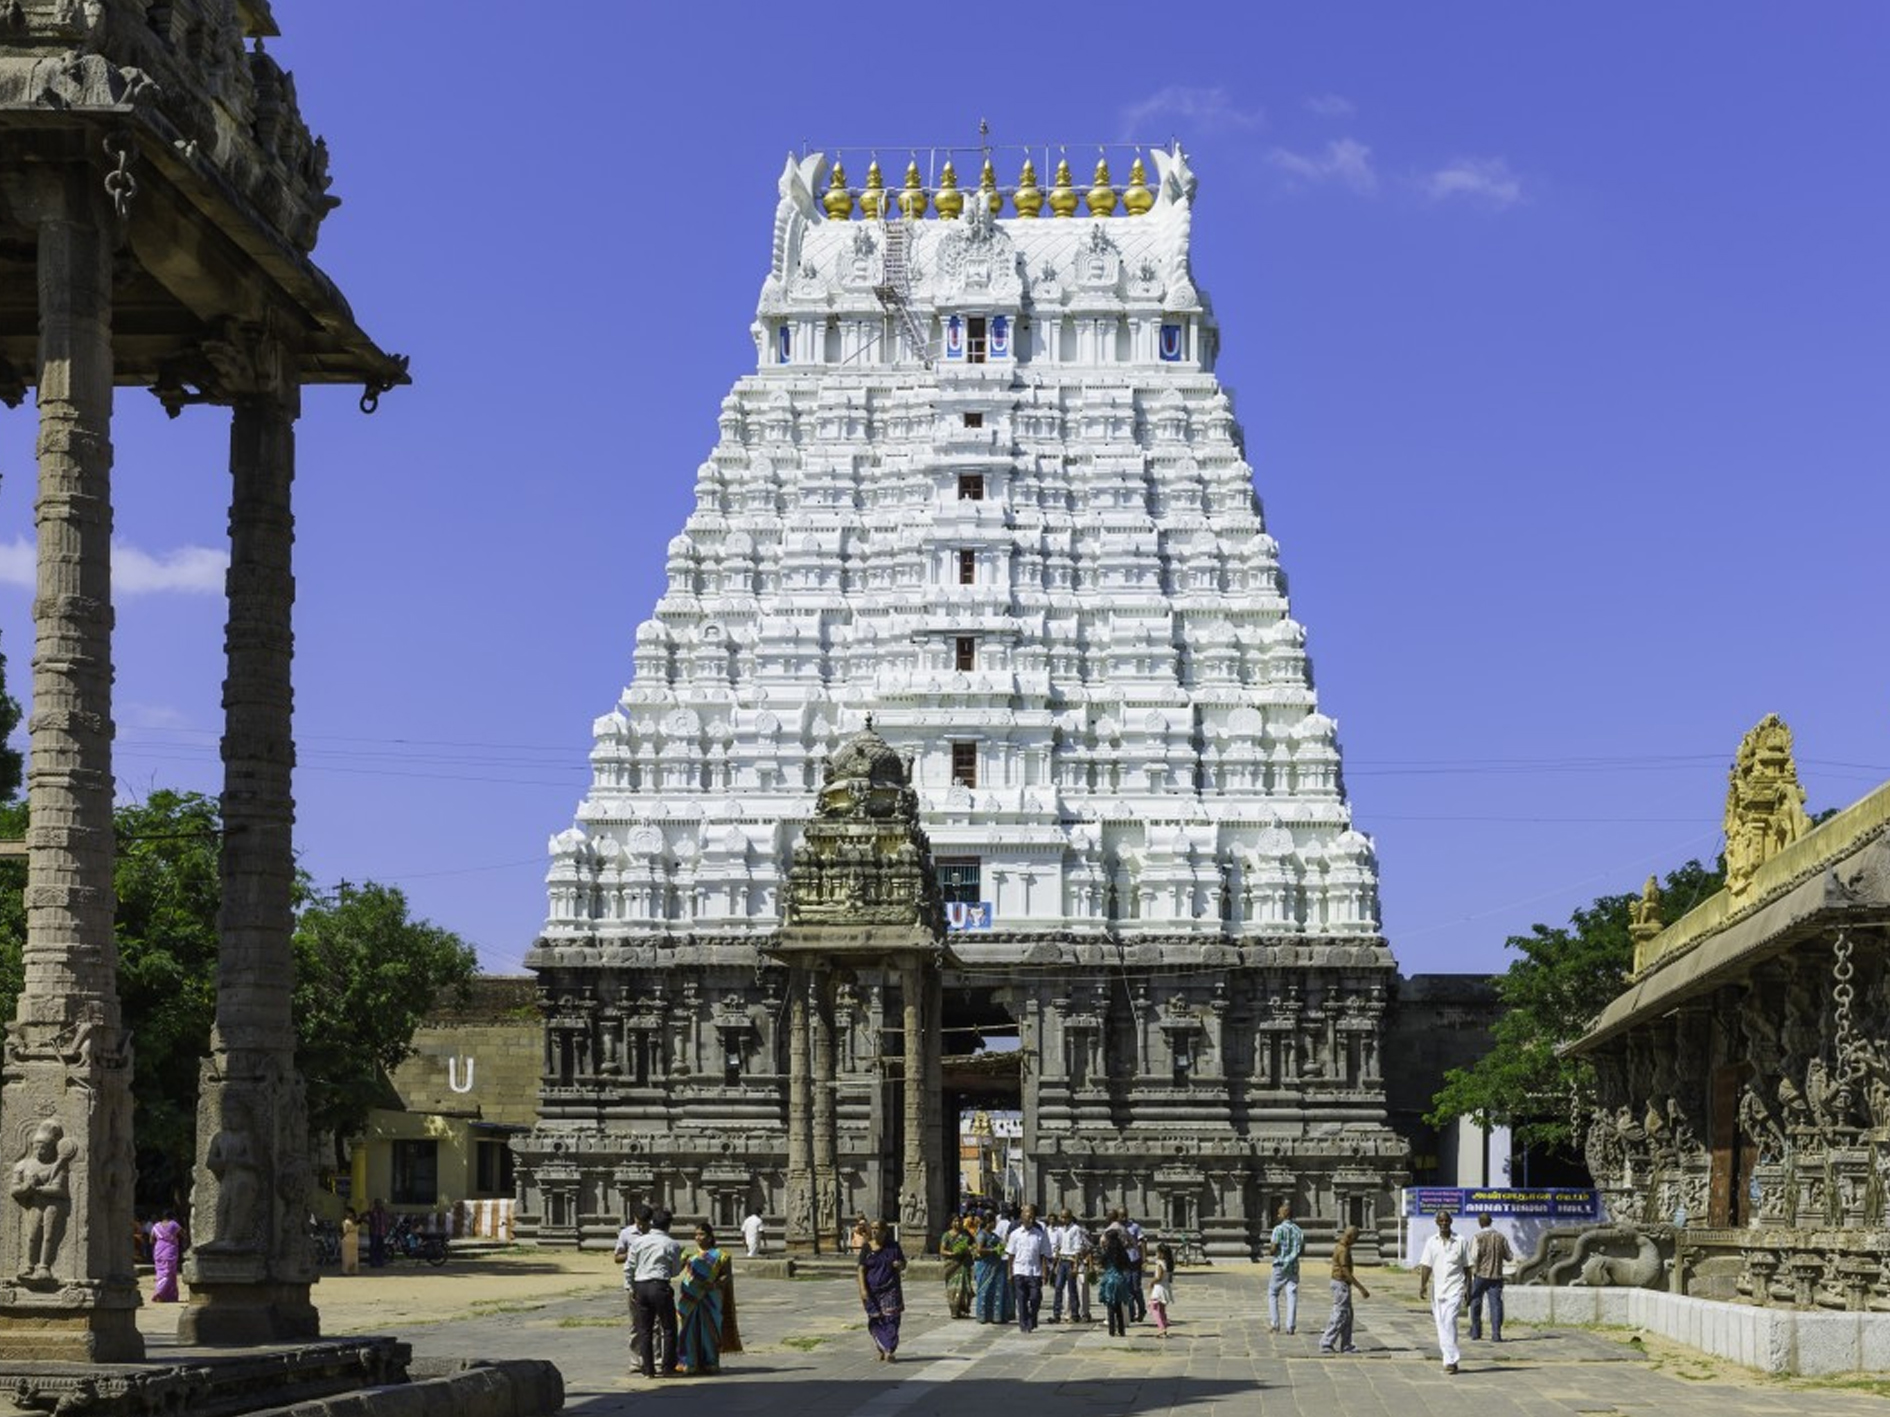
xmin=140 ymin=1251 xmax=1890 ymax=1417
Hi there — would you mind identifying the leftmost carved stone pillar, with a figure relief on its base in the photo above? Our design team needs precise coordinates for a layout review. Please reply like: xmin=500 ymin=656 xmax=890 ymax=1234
xmin=0 ymin=166 xmax=144 ymax=1362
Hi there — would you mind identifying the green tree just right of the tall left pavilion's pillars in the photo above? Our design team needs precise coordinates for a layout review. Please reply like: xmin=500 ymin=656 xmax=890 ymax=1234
xmin=295 ymin=880 xmax=478 ymax=1164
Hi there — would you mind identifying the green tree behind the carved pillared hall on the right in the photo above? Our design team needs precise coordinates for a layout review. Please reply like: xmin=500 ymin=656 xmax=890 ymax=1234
xmin=1425 ymin=862 xmax=1726 ymax=1147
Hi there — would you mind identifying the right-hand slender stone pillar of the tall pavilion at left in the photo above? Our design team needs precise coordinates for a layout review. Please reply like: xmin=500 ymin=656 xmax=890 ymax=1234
xmin=178 ymin=327 xmax=321 ymax=1343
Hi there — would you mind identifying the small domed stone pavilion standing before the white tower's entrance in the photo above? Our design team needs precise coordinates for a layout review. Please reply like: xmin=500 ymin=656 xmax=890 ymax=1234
xmin=769 ymin=718 xmax=945 ymax=1253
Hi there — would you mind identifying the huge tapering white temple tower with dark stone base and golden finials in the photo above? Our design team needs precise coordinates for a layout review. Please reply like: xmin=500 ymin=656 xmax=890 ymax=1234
xmin=520 ymin=149 xmax=1404 ymax=1255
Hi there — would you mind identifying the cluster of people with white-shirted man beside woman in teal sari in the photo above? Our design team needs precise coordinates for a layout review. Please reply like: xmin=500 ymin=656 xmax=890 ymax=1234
xmin=616 ymin=1205 xmax=740 ymax=1377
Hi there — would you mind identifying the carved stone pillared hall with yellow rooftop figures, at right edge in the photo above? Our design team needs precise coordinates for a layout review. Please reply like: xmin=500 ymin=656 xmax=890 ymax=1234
xmin=1557 ymin=718 xmax=1890 ymax=1311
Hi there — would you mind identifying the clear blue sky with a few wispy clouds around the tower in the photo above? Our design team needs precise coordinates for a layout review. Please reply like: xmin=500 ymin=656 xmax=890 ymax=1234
xmin=0 ymin=0 xmax=1890 ymax=971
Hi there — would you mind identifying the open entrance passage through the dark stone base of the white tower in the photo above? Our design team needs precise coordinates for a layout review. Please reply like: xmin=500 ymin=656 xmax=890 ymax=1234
xmin=939 ymin=979 xmax=1026 ymax=1209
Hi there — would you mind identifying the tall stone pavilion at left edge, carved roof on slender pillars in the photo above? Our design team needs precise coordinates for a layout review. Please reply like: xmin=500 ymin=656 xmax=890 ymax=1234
xmin=0 ymin=0 xmax=406 ymax=1362
